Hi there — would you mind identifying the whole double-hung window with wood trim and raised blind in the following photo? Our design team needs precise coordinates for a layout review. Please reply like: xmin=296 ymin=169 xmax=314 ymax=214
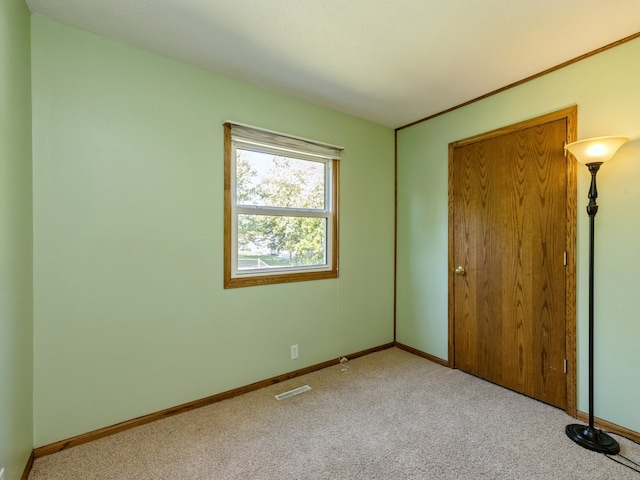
xmin=224 ymin=123 xmax=342 ymax=288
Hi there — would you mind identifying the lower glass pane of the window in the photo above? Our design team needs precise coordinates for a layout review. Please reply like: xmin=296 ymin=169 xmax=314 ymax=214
xmin=238 ymin=214 xmax=327 ymax=270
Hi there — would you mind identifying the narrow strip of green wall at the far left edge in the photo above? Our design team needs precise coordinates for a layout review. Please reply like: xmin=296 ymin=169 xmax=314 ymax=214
xmin=0 ymin=0 xmax=33 ymax=480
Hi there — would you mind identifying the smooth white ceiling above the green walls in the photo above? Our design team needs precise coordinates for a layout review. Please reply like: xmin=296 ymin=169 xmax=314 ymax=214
xmin=27 ymin=0 xmax=640 ymax=128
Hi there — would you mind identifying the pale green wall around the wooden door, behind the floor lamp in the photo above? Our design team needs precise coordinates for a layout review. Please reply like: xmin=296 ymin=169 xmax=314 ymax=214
xmin=397 ymin=34 xmax=640 ymax=431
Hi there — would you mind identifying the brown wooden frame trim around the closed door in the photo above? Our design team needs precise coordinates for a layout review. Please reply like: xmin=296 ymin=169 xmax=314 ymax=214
xmin=448 ymin=105 xmax=578 ymax=417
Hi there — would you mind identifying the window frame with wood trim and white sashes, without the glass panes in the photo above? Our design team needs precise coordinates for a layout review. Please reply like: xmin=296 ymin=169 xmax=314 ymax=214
xmin=224 ymin=122 xmax=342 ymax=288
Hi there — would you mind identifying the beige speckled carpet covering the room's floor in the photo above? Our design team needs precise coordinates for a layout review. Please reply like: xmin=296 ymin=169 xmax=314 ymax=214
xmin=29 ymin=348 xmax=640 ymax=480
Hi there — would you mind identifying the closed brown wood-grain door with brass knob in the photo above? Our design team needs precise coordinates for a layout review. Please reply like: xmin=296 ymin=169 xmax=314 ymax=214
xmin=450 ymin=114 xmax=569 ymax=408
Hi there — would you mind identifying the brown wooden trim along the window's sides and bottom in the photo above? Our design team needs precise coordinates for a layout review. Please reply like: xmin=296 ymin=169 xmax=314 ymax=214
xmin=223 ymin=122 xmax=341 ymax=289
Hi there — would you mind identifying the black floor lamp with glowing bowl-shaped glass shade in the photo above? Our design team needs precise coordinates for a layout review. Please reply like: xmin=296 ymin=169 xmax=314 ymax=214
xmin=565 ymin=137 xmax=629 ymax=455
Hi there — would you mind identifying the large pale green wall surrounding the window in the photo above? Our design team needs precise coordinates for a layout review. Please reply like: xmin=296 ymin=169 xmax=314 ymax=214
xmin=32 ymin=16 xmax=394 ymax=446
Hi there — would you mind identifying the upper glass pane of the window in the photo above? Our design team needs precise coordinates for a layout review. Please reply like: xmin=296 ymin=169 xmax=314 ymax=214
xmin=236 ymin=148 xmax=326 ymax=210
